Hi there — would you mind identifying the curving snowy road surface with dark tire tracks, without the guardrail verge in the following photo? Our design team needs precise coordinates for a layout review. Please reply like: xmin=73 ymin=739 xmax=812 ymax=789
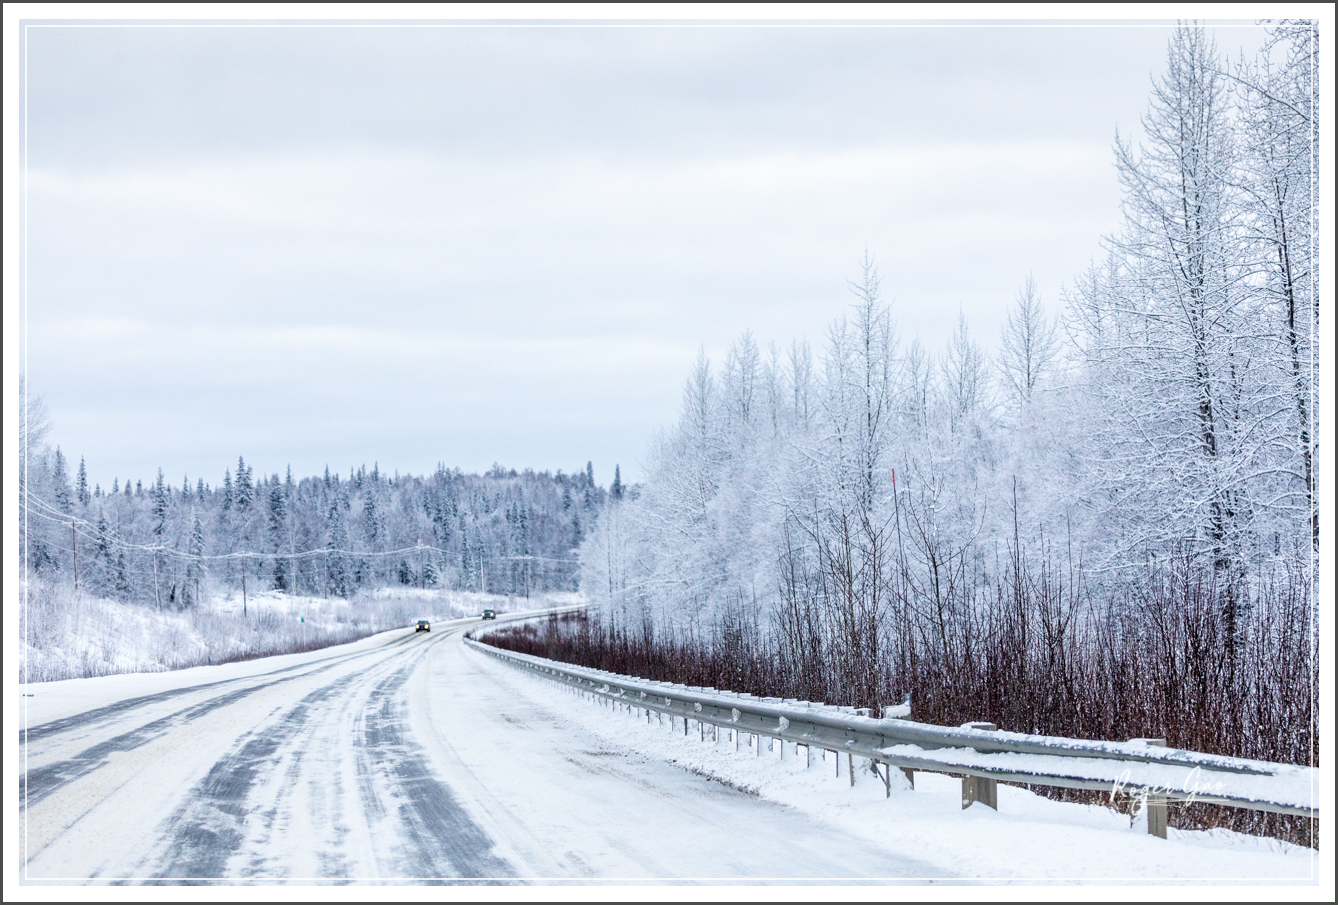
xmin=20 ymin=624 xmax=945 ymax=882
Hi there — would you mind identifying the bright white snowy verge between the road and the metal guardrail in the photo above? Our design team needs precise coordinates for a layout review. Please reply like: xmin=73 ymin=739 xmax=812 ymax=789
xmin=479 ymin=657 xmax=1318 ymax=884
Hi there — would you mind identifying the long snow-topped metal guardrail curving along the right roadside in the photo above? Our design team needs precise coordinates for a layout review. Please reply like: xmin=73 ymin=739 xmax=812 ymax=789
xmin=466 ymin=615 xmax=1319 ymax=838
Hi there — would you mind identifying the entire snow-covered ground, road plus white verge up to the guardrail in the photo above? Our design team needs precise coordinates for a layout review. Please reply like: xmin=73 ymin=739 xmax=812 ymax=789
xmin=15 ymin=610 xmax=1322 ymax=896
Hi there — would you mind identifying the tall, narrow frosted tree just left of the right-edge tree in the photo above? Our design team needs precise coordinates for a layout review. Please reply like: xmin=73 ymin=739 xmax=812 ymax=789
xmin=1070 ymin=27 xmax=1274 ymax=581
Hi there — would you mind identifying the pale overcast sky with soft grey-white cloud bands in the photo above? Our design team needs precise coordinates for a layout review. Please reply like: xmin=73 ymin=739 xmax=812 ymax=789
xmin=24 ymin=17 xmax=1263 ymax=490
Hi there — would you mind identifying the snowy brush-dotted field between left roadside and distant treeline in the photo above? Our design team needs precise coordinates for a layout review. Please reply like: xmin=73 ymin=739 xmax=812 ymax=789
xmin=20 ymin=585 xmax=571 ymax=681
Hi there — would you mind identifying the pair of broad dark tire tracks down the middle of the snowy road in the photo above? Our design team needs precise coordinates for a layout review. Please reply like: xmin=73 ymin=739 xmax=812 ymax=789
xmin=140 ymin=636 xmax=515 ymax=884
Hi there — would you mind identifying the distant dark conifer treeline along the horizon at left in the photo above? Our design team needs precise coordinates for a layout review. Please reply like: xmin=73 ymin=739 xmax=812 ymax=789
xmin=19 ymin=412 xmax=621 ymax=608
